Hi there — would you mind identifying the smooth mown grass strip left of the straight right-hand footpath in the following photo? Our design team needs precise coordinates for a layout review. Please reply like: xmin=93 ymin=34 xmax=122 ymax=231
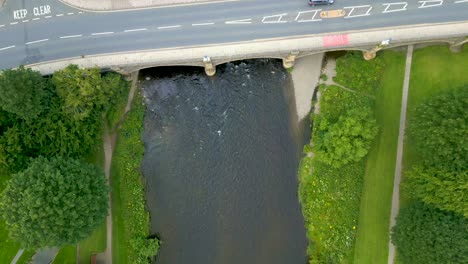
xmin=354 ymin=51 xmax=406 ymax=264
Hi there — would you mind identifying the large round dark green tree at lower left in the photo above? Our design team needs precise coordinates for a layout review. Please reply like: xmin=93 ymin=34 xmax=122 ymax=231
xmin=0 ymin=157 xmax=108 ymax=248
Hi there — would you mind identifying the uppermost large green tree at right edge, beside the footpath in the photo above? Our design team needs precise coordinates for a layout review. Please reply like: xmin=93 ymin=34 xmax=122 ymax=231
xmin=409 ymin=86 xmax=468 ymax=169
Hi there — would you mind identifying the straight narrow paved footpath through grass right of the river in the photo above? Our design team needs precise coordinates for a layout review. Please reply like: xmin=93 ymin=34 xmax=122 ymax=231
xmin=388 ymin=45 xmax=413 ymax=264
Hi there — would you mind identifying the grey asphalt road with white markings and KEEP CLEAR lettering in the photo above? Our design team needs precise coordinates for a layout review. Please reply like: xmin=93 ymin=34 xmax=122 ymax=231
xmin=0 ymin=0 xmax=468 ymax=69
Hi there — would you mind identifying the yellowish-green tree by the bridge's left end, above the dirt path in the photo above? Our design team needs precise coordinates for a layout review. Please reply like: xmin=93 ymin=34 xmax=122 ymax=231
xmin=52 ymin=65 xmax=125 ymax=120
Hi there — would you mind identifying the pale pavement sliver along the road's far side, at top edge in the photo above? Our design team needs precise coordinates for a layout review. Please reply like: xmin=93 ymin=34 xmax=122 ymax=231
xmin=58 ymin=0 xmax=225 ymax=11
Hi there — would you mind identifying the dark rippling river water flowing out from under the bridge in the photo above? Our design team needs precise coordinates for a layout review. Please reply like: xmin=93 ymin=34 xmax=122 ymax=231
xmin=140 ymin=60 xmax=306 ymax=264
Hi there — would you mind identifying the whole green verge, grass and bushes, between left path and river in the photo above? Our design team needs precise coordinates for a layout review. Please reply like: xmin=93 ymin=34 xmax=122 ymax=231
xmin=111 ymin=90 xmax=159 ymax=263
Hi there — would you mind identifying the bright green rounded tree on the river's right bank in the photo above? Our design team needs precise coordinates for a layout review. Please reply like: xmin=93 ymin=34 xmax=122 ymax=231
xmin=314 ymin=107 xmax=378 ymax=168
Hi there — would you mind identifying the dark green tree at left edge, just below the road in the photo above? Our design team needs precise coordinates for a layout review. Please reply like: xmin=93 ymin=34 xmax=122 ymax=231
xmin=0 ymin=66 xmax=50 ymax=121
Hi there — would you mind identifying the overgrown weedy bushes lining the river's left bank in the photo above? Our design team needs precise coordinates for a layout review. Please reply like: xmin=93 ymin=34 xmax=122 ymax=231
xmin=113 ymin=92 xmax=159 ymax=263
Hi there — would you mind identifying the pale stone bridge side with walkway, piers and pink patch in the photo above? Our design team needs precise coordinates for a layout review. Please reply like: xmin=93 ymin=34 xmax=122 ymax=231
xmin=28 ymin=22 xmax=468 ymax=76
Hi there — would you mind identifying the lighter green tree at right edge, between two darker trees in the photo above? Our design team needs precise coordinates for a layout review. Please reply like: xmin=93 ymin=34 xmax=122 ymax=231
xmin=405 ymin=165 xmax=468 ymax=217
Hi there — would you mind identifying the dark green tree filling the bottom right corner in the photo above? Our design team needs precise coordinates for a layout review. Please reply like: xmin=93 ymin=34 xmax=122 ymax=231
xmin=392 ymin=201 xmax=468 ymax=264
